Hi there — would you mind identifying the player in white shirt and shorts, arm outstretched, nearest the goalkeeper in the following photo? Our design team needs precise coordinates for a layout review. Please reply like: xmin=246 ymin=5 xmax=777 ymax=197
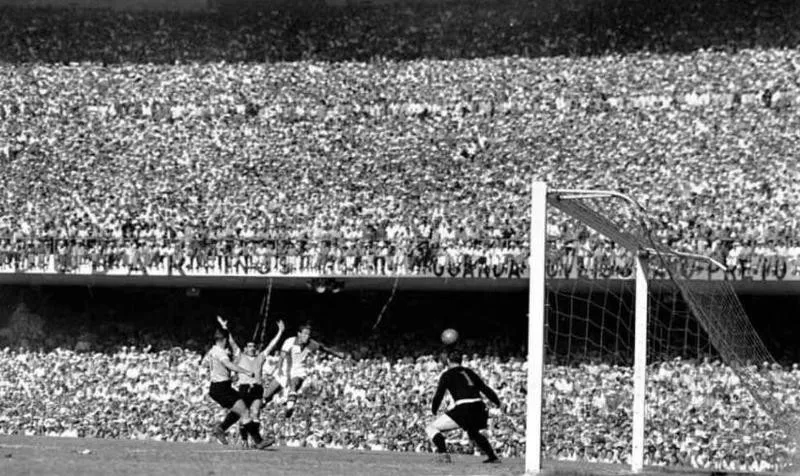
xmin=264 ymin=323 xmax=344 ymax=418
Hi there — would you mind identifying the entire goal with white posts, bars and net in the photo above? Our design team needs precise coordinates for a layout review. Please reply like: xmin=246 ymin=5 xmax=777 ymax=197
xmin=525 ymin=182 xmax=800 ymax=474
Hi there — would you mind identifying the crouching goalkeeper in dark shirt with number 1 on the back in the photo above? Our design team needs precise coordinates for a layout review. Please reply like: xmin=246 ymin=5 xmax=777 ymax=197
xmin=425 ymin=351 xmax=500 ymax=463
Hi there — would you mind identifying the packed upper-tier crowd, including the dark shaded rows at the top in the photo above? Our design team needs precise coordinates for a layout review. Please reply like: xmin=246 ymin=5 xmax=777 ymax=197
xmin=0 ymin=1 xmax=800 ymax=273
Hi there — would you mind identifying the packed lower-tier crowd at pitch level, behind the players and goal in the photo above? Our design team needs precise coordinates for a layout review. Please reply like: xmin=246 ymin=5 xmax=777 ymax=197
xmin=0 ymin=336 xmax=800 ymax=471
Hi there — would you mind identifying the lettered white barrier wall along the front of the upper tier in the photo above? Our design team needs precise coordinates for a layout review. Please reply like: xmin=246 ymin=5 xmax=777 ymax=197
xmin=0 ymin=249 xmax=800 ymax=290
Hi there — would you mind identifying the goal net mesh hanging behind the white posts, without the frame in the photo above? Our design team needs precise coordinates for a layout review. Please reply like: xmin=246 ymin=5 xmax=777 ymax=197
xmin=543 ymin=190 xmax=800 ymax=469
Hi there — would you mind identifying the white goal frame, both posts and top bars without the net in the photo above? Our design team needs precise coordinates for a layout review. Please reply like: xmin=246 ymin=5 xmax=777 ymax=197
xmin=525 ymin=181 xmax=726 ymax=475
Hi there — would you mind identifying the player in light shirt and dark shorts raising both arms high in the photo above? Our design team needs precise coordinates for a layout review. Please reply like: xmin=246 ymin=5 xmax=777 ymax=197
xmin=225 ymin=321 xmax=286 ymax=446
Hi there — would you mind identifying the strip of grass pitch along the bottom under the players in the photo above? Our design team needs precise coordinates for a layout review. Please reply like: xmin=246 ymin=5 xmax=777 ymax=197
xmin=0 ymin=436 xmax=776 ymax=476
